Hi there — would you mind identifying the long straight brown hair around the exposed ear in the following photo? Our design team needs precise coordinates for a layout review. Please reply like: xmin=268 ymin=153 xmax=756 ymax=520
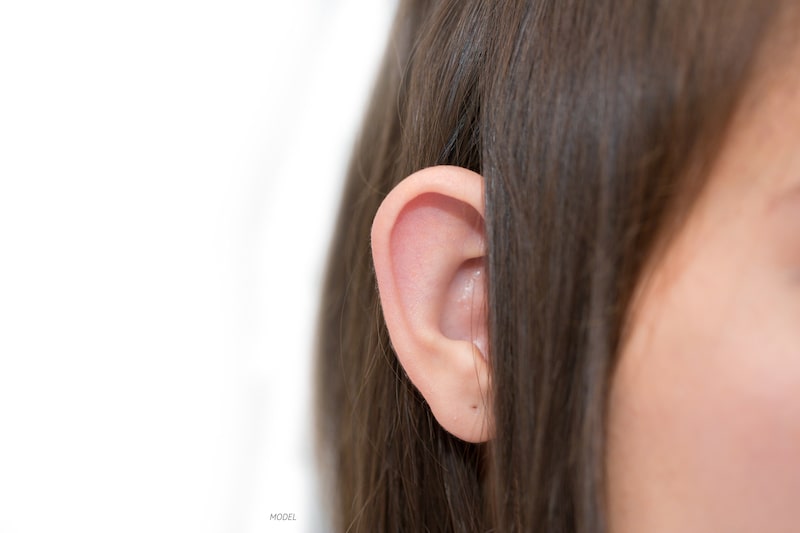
xmin=317 ymin=0 xmax=778 ymax=532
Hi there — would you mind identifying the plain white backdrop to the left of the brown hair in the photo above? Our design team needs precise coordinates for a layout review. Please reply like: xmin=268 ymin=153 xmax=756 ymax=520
xmin=0 ymin=0 xmax=395 ymax=533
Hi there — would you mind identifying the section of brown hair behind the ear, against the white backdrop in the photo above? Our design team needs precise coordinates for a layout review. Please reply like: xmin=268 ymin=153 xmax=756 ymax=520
xmin=315 ymin=0 xmax=491 ymax=533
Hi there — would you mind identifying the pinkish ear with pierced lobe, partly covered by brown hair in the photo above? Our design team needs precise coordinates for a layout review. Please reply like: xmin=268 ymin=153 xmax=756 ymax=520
xmin=372 ymin=166 xmax=494 ymax=442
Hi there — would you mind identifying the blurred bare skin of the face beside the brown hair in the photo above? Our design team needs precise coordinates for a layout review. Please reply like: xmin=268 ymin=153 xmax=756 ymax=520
xmin=606 ymin=47 xmax=800 ymax=533
